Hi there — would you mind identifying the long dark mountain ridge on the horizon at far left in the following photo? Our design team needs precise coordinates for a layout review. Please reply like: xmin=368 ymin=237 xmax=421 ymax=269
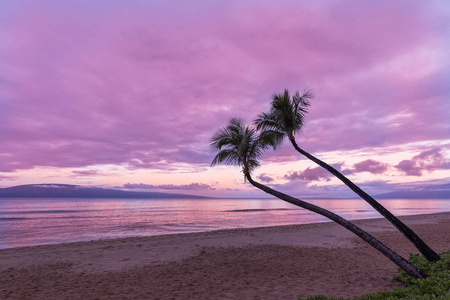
xmin=0 ymin=184 xmax=212 ymax=199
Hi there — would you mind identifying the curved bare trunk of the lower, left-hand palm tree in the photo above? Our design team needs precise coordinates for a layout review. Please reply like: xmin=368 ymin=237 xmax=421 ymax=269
xmin=245 ymin=173 xmax=427 ymax=279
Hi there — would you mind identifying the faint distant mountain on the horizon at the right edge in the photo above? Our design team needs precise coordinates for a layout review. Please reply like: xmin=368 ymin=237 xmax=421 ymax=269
xmin=375 ymin=184 xmax=450 ymax=199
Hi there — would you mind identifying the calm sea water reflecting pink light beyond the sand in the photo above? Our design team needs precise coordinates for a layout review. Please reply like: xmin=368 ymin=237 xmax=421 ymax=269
xmin=0 ymin=198 xmax=450 ymax=248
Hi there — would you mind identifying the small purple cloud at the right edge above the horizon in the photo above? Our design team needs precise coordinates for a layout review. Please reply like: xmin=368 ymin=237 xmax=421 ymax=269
xmin=395 ymin=147 xmax=450 ymax=176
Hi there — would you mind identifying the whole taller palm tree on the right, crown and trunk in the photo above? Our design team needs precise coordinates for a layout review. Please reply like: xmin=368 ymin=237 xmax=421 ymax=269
xmin=254 ymin=89 xmax=441 ymax=262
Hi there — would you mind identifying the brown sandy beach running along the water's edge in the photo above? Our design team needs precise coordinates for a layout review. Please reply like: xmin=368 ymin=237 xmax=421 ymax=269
xmin=0 ymin=212 xmax=450 ymax=299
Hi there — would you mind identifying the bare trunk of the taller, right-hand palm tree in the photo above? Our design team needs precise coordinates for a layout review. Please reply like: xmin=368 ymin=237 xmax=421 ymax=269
xmin=289 ymin=137 xmax=441 ymax=262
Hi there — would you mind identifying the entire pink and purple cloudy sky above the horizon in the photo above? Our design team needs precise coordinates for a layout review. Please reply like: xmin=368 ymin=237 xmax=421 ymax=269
xmin=0 ymin=0 xmax=450 ymax=197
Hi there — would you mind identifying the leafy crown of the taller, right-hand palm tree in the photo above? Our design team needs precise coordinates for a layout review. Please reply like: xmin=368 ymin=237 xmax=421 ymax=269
xmin=254 ymin=89 xmax=313 ymax=139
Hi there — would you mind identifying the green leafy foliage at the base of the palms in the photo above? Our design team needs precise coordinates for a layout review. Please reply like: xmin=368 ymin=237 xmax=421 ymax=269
xmin=299 ymin=252 xmax=450 ymax=300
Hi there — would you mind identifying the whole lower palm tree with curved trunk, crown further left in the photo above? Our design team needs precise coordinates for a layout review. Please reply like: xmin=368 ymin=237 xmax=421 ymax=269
xmin=211 ymin=119 xmax=426 ymax=279
